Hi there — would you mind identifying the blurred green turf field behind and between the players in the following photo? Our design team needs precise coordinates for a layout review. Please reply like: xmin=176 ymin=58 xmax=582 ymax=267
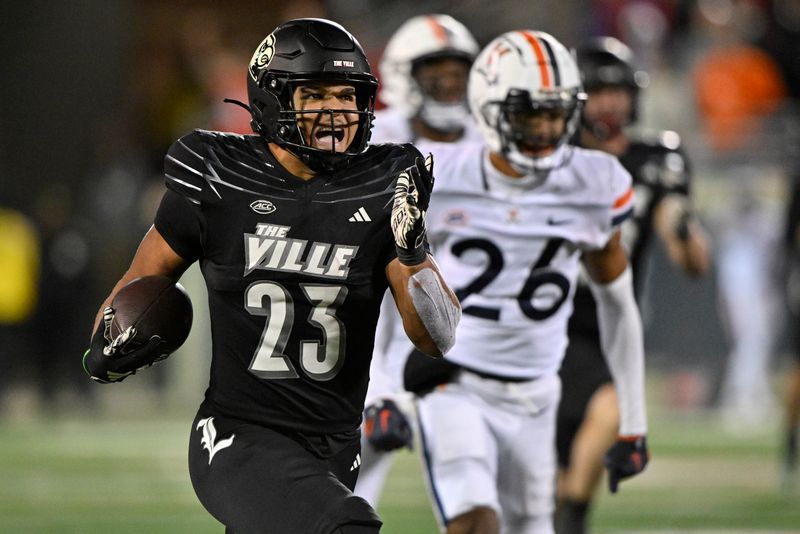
xmin=0 ymin=392 xmax=800 ymax=534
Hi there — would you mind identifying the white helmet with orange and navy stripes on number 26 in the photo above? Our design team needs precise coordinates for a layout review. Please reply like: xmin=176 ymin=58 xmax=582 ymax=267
xmin=469 ymin=30 xmax=586 ymax=174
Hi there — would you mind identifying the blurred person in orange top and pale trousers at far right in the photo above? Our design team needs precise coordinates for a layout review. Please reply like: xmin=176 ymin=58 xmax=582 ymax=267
xmin=694 ymin=0 xmax=787 ymax=430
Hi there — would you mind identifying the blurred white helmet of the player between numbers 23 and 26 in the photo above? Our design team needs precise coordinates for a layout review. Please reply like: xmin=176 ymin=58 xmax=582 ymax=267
xmin=380 ymin=15 xmax=479 ymax=131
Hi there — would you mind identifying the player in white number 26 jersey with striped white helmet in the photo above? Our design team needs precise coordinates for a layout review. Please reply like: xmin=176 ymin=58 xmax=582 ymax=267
xmin=406 ymin=30 xmax=649 ymax=534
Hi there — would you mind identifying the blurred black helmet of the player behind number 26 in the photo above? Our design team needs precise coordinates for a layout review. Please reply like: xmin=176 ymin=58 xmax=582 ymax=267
xmin=575 ymin=37 xmax=648 ymax=123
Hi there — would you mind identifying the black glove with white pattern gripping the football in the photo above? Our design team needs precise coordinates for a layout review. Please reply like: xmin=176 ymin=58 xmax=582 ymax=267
xmin=83 ymin=306 xmax=169 ymax=384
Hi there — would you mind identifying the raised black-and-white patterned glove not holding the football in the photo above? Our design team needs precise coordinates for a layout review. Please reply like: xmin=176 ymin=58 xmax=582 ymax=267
xmin=391 ymin=154 xmax=433 ymax=265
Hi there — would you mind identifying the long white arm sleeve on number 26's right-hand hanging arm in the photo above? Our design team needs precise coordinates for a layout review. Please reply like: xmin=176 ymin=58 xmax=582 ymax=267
xmin=590 ymin=267 xmax=647 ymax=436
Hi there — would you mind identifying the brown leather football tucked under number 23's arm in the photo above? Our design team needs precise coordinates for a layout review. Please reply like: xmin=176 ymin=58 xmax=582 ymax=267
xmin=111 ymin=276 xmax=192 ymax=353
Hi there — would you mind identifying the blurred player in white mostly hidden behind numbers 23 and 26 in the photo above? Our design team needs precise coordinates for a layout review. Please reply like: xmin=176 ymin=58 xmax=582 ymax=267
xmin=355 ymin=14 xmax=482 ymax=506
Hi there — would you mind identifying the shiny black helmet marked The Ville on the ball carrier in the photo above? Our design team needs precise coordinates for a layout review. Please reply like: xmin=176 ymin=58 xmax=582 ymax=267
xmin=247 ymin=19 xmax=378 ymax=171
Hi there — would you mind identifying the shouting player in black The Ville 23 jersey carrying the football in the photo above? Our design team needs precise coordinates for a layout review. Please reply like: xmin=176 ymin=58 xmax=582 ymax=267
xmin=84 ymin=19 xmax=460 ymax=534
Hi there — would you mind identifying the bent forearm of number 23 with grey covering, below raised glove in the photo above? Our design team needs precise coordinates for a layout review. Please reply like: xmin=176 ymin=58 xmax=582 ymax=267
xmin=389 ymin=256 xmax=461 ymax=357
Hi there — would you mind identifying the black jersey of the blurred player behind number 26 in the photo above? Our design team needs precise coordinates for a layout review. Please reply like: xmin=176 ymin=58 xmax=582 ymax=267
xmin=570 ymin=132 xmax=691 ymax=333
